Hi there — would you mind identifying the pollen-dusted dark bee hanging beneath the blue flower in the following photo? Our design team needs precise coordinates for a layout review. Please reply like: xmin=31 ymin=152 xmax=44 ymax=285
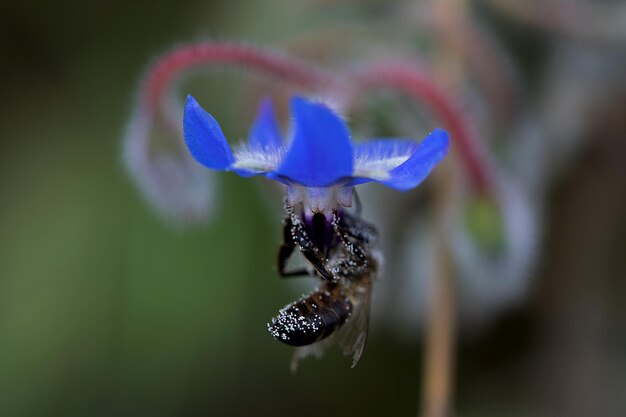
xmin=268 ymin=203 xmax=379 ymax=371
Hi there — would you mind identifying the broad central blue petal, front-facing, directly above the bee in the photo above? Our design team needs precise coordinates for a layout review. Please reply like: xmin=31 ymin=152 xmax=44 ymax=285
xmin=269 ymin=97 xmax=353 ymax=187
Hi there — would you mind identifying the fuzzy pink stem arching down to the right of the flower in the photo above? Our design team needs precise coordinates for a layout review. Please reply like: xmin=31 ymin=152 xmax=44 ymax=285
xmin=358 ymin=64 xmax=494 ymax=192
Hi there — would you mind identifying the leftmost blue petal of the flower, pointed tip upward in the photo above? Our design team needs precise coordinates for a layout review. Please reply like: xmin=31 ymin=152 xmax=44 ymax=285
xmin=183 ymin=95 xmax=235 ymax=171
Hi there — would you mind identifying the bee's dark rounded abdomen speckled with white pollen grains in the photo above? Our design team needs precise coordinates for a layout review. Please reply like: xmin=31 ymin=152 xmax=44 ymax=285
xmin=267 ymin=284 xmax=352 ymax=346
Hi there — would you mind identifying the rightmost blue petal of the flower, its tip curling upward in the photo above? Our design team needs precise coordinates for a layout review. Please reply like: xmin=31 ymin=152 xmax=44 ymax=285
xmin=350 ymin=129 xmax=449 ymax=191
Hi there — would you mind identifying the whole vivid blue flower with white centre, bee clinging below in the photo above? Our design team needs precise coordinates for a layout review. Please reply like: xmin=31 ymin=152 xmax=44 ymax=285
xmin=183 ymin=95 xmax=449 ymax=214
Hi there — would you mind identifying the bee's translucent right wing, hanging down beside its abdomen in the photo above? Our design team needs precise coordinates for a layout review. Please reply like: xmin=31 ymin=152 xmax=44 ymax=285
xmin=338 ymin=281 xmax=372 ymax=368
